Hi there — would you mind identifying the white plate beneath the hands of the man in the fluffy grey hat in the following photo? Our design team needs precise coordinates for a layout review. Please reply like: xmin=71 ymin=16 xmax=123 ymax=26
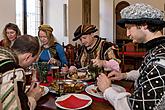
xmin=85 ymin=84 xmax=126 ymax=98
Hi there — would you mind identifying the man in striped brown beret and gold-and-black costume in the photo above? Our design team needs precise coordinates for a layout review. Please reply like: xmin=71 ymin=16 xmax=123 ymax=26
xmin=70 ymin=25 xmax=120 ymax=71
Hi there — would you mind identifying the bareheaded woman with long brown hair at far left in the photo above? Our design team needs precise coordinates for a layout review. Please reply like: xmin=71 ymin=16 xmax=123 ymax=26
xmin=0 ymin=23 xmax=21 ymax=48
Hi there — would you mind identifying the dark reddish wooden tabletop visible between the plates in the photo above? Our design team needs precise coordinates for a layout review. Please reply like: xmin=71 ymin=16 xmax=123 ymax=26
xmin=35 ymin=76 xmax=133 ymax=110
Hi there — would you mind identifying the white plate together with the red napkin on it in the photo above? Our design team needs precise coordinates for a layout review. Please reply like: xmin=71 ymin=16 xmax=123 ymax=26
xmin=55 ymin=94 xmax=92 ymax=110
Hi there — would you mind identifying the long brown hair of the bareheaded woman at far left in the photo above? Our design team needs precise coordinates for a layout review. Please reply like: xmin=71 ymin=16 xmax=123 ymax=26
xmin=3 ymin=23 xmax=21 ymax=47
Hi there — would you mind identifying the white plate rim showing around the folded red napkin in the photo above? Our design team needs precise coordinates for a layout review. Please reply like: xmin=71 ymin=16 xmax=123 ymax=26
xmin=55 ymin=94 xmax=92 ymax=110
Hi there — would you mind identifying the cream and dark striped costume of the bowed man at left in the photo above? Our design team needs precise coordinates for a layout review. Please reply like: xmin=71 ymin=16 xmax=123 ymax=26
xmin=0 ymin=47 xmax=36 ymax=110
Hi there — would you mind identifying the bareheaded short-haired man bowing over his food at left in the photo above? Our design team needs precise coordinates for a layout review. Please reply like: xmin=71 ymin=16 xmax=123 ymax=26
xmin=0 ymin=35 xmax=43 ymax=110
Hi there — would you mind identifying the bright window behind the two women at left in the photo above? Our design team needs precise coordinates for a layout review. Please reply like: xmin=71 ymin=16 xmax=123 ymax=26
xmin=16 ymin=0 xmax=43 ymax=36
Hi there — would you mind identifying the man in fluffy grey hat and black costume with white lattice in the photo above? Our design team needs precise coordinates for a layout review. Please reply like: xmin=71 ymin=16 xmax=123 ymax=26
xmin=97 ymin=3 xmax=165 ymax=110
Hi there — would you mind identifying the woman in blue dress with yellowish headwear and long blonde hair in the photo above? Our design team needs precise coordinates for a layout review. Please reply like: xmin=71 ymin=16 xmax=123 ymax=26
xmin=38 ymin=24 xmax=68 ymax=69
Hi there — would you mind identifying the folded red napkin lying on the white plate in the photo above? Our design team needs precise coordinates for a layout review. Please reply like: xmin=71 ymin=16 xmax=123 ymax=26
xmin=56 ymin=95 xmax=90 ymax=109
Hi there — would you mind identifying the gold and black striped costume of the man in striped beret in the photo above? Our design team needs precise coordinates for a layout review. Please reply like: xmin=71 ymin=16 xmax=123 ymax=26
xmin=76 ymin=36 xmax=120 ymax=68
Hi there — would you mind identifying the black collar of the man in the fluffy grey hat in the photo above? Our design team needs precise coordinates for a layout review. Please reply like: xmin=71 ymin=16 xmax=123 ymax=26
xmin=145 ymin=36 xmax=165 ymax=51
